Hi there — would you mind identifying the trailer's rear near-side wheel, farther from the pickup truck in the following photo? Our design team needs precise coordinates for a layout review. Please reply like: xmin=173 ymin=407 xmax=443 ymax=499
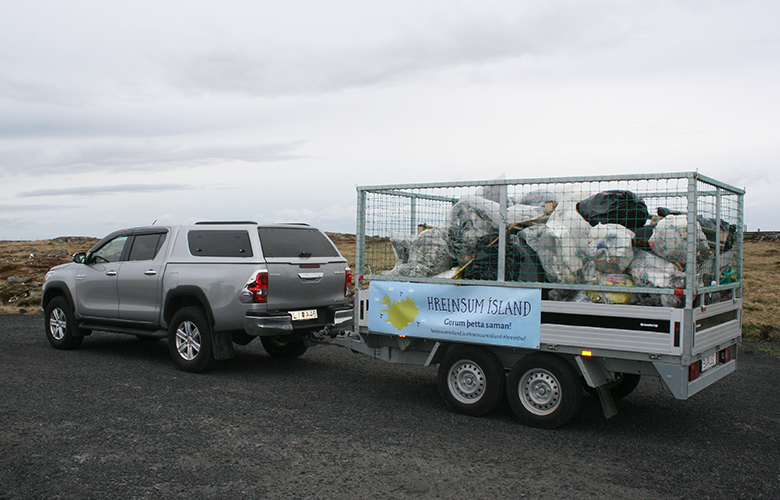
xmin=506 ymin=354 xmax=582 ymax=429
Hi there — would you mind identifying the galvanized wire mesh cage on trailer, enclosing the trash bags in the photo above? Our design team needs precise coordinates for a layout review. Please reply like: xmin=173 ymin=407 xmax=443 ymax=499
xmin=356 ymin=172 xmax=744 ymax=307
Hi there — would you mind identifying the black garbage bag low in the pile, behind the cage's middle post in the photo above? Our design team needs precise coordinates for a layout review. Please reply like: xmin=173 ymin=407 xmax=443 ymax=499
xmin=463 ymin=234 xmax=546 ymax=282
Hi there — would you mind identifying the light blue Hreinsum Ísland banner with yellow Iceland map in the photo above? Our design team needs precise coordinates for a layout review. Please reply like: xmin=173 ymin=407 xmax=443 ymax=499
xmin=368 ymin=281 xmax=542 ymax=349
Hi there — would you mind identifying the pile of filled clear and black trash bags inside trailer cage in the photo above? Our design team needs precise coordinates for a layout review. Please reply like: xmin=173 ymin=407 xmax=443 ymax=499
xmin=384 ymin=190 xmax=736 ymax=307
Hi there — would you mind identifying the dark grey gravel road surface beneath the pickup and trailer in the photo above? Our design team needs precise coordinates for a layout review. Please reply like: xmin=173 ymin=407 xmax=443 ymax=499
xmin=0 ymin=315 xmax=780 ymax=500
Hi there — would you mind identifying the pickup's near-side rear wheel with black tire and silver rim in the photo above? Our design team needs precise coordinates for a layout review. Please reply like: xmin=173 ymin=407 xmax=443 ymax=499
xmin=168 ymin=306 xmax=215 ymax=373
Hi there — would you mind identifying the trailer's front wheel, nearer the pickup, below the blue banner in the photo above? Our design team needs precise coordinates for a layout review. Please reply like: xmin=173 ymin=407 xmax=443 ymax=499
xmin=438 ymin=345 xmax=506 ymax=417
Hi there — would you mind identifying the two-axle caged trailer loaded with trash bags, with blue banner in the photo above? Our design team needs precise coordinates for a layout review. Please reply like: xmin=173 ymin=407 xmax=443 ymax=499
xmin=330 ymin=172 xmax=744 ymax=428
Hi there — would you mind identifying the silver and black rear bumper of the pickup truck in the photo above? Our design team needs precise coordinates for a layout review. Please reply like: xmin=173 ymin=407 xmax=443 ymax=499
xmin=244 ymin=307 xmax=352 ymax=337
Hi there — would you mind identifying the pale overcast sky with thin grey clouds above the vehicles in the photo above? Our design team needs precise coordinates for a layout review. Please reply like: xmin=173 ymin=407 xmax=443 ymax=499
xmin=0 ymin=0 xmax=780 ymax=240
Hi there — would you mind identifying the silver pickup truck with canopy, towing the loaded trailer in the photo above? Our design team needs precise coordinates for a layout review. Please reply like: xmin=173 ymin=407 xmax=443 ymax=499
xmin=42 ymin=222 xmax=352 ymax=372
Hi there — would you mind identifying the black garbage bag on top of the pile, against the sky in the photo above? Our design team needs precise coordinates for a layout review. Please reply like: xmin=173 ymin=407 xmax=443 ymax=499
xmin=577 ymin=190 xmax=648 ymax=232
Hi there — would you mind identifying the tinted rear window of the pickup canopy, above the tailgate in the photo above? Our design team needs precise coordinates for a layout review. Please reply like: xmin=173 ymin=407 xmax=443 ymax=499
xmin=257 ymin=227 xmax=339 ymax=257
